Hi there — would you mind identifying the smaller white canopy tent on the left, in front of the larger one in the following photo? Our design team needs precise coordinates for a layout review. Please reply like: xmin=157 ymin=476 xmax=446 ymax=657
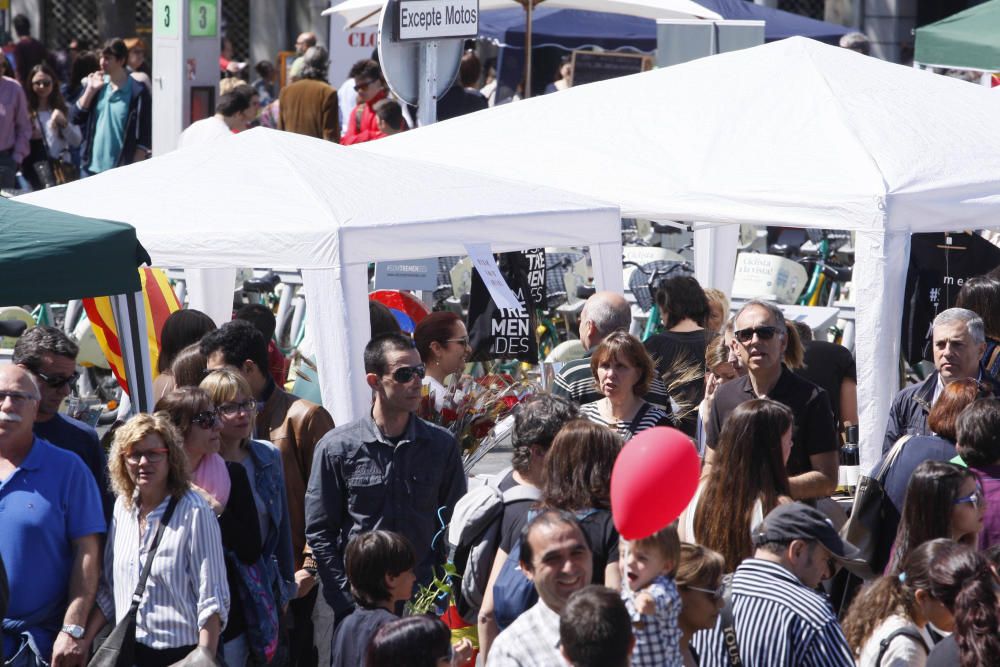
xmin=22 ymin=129 xmax=622 ymax=423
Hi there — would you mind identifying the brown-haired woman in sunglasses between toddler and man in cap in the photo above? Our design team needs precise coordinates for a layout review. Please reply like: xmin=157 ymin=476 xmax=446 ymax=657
xmin=674 ymin=542 xmax=726 ymax=667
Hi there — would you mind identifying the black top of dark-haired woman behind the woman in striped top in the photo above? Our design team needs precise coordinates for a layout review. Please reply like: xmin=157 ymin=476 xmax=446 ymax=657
xmin=645 ymin=329 xmax=708 ymax=438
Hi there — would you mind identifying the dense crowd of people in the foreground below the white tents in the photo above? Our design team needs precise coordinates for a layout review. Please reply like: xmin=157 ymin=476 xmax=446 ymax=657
xmin=0 ymin=266 xmax=1000 ymax=667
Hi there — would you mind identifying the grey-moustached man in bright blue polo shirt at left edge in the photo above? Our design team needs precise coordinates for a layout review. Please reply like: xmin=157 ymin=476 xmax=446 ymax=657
xmin=0 ymin=366 xmax=106 ymax=666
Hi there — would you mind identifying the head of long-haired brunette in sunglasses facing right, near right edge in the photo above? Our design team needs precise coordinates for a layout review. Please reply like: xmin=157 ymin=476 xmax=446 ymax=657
xmin=886 ymin=461 xmax=985 ymax=574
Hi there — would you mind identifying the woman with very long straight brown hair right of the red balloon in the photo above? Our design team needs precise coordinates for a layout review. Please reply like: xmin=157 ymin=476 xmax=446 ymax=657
xmin=680 ymin=398 xmax=792 ymax=572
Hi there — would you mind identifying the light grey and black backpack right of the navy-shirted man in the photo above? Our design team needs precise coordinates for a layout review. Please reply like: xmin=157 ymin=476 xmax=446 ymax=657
xmin=448 ymin=468 xmax=542 ymax=623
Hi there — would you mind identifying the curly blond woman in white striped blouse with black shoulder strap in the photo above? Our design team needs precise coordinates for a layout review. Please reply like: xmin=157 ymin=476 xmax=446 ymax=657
xmin=83 ymin=413 xmax=230 ymax=667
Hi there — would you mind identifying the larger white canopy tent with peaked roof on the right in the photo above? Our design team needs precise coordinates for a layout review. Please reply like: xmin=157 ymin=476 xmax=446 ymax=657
xmin=363 ymin=38 xmax=1000 ymax=466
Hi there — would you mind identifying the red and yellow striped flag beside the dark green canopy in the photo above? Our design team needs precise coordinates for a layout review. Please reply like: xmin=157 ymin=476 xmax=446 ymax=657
xmin=83 ymin=267 xmax=181 ymax=391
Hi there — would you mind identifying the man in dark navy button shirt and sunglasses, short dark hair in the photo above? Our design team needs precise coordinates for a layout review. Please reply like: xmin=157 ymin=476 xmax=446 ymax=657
xmin=306 ymin=333 xmax=466 ymax=631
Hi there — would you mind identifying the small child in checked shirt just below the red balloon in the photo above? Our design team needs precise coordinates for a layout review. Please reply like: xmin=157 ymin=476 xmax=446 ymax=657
xmin=619 ymin=521 xmax=683 ymax=667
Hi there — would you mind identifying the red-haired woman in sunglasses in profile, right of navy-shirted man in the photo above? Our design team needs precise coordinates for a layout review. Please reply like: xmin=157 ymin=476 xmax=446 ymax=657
xmin=413 ymin=311 xmax=472 ymax=412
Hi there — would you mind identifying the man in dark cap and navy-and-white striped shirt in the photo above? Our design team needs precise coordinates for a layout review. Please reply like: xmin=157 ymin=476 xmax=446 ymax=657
xmin=691 ymin=503 xmax=858 ymax=667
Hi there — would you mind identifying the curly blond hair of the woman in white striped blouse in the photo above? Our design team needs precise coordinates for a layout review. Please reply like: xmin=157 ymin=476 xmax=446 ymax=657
xmin=108 ymin=412 xmax=191 ymax=508
